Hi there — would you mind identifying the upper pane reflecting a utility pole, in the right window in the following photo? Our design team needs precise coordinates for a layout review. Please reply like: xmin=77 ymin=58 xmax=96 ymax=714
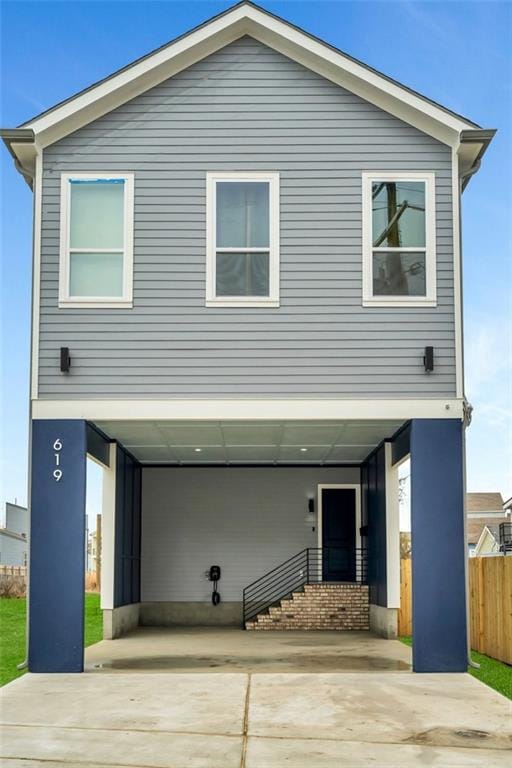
xmin=372 ymin=181 xmax=425 ymax=248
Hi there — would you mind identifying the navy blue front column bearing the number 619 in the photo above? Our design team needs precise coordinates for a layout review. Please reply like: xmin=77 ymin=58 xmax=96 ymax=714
xmin=28 ymin=419 xmax=87 ymax=672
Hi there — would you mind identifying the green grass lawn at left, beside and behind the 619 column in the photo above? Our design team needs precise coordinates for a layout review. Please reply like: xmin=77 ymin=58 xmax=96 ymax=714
xmin=0 ymin=592 xmax=103 ymax=685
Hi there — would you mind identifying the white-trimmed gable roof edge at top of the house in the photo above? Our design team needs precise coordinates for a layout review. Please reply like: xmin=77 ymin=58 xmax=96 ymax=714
xmin=0 ymin=0 xmax=494 ymax=184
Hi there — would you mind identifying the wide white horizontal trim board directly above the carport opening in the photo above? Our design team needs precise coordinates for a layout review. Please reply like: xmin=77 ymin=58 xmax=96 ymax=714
xmin=32 ymin=398 xmax=464 ymax=421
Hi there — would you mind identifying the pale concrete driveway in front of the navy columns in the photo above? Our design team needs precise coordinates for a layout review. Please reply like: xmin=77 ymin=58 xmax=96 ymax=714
xmin=0 ymin=633 xmax=512 ymax=768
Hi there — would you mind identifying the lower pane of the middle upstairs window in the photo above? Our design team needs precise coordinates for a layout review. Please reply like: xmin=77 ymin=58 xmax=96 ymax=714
xmin=216 ymin=253 xmax=269 ymax=296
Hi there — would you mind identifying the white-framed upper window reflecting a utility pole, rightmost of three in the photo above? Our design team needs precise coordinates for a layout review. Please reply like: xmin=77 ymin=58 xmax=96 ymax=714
xmin=363 ymin=172 xmax=436 ymax=307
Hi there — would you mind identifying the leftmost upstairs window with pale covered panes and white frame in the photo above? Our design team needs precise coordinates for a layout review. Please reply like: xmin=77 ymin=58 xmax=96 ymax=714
xmin=59 ymin=173 xmax=133 ymax=307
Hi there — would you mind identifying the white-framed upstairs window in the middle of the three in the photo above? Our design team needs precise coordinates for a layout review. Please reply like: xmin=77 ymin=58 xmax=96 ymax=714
xmin=206 ymin=172 xmax=279 ymax=307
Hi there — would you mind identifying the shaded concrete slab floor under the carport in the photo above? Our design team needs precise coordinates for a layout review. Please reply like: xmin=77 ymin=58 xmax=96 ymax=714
xmin=85 ymin=627 xmax=411 ymax=673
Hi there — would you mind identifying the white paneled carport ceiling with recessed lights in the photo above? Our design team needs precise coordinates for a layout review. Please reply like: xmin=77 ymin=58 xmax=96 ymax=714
xmin=97 ymin=421 xmax=401 ymax=465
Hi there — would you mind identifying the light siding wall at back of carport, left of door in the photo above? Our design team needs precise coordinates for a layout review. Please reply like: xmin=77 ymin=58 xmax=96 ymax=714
xmin=141 ymin=467 xmax=360 ymax=602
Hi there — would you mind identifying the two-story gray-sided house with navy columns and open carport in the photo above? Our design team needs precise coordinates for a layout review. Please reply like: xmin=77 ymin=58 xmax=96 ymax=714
xmin=2 ymin=2 xmax=494 ymax=671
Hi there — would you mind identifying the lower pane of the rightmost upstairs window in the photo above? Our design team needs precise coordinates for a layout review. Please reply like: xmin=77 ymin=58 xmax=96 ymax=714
xmin=373 ymin=251 xmax=426 ymax=296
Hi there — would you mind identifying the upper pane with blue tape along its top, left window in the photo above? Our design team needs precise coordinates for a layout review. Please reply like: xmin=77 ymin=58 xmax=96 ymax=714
xmin=70 ymin=180 xmax=124 ymax=248
